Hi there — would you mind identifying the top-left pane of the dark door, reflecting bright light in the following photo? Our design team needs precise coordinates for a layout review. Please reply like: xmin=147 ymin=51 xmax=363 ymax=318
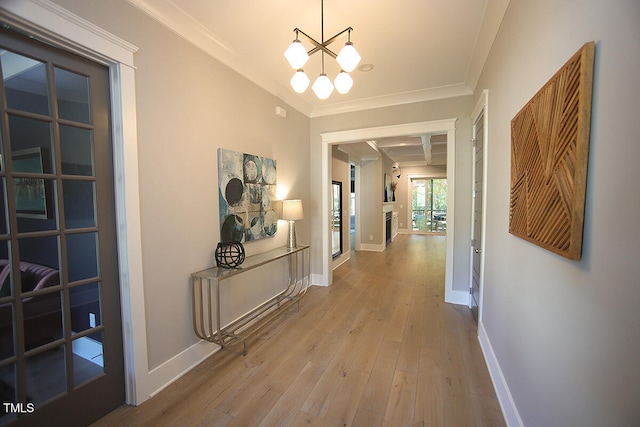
xmin=0 ymin=49 xmax=49 ymax=115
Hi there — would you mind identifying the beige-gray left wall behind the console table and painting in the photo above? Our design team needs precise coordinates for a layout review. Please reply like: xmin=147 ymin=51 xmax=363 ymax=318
xmin=51 ymin=0 xmax=310 ymax=372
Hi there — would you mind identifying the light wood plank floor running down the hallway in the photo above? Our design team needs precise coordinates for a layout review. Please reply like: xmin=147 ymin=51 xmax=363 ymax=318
xmin=95 ymin=235 xmax=504 ymax=427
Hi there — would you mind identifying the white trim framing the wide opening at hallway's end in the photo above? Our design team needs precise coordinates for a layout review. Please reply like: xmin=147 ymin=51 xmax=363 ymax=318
xmin=319 ymin=118 xmax=468 ymax=304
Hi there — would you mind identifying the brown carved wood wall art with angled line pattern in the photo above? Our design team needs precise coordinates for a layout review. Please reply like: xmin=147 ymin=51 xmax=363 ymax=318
xmin=509 ymin=42 xmax=595 ymax=260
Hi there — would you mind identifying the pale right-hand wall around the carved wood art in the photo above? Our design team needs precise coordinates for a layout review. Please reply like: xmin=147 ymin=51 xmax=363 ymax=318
xmin=478 ymin=0 xmax=640 ymax=427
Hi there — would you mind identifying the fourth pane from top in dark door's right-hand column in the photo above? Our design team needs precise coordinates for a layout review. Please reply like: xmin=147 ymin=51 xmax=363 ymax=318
xmin=67 ymin=233 xmax=98 ymax=282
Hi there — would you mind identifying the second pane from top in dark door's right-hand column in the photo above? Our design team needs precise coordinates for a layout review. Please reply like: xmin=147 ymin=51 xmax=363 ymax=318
xmin=60 ymin=126 xmax=94 ymax=176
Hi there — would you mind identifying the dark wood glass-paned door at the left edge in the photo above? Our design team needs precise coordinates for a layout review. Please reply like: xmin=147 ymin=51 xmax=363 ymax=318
xmin=0 ymin=29 xmax=124 ymax=426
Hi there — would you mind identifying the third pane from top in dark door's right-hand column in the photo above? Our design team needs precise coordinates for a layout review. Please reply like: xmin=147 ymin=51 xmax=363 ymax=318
xmin=62 ymin=179 xmax=96 ymax=228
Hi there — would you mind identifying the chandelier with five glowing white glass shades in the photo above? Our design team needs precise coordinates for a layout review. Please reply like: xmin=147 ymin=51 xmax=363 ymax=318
xmin=284 ymin=1 xmax=361 ymax=99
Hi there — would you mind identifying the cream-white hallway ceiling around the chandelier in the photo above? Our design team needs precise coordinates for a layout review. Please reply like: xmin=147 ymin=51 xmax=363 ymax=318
xmin=128 ymin=0 xmax=509 ymax=166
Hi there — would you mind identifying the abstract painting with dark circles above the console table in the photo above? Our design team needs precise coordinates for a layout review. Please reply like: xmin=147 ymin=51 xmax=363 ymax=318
xmin=218 ymin=148 xmax=278 ymax=242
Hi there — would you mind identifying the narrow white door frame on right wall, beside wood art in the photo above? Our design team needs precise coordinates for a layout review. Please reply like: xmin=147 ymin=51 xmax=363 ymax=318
xmin=469 ymin=89 xmax=489 ymax=323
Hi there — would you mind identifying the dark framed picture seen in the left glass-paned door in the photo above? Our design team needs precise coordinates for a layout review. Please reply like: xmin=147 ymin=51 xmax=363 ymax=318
xmin=11 ymin=147 xmax=49 ymax=219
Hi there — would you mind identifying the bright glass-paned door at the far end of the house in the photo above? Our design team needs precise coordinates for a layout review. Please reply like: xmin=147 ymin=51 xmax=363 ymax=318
xmin=411 ymin=178 xmax=447 ymax=233
